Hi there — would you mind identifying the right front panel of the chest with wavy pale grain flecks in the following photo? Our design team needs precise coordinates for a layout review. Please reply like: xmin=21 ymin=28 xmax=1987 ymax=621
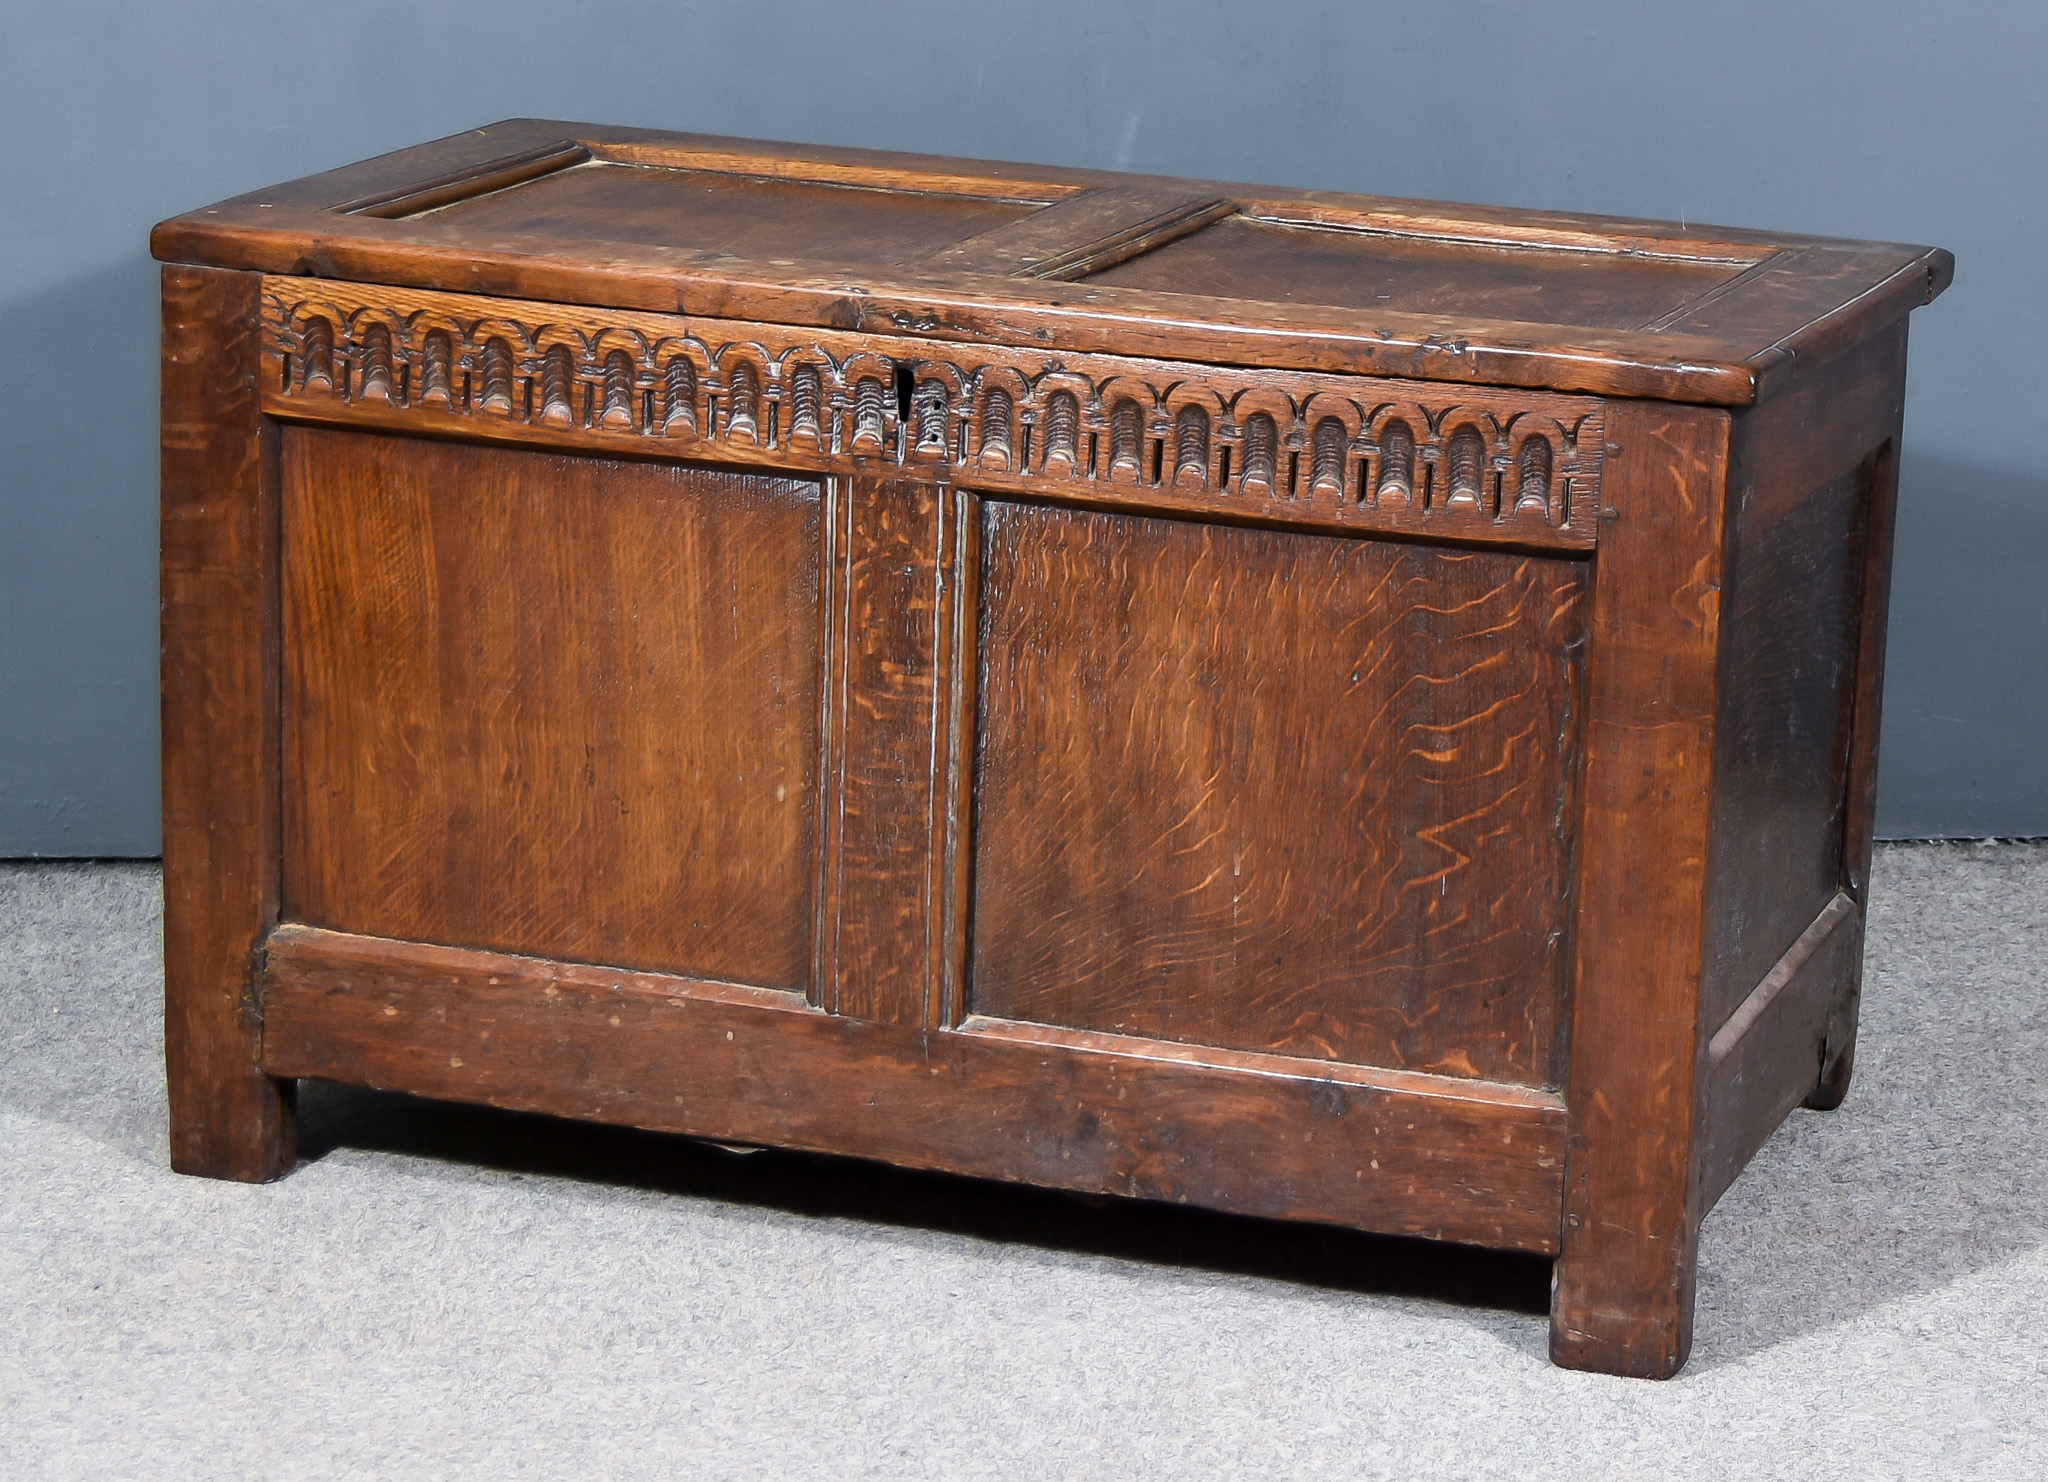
xmin=967 ymin=499 xmax=1585 ymax=1085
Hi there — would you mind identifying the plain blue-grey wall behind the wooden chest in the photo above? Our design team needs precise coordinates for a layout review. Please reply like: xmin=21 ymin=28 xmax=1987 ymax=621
xmin=0 ymin=0 xmax=2048 ymax=856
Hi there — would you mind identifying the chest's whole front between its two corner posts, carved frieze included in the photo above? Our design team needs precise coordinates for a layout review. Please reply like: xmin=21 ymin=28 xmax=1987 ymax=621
xmin=243 ymin=280 xmax=1581 ymax=1251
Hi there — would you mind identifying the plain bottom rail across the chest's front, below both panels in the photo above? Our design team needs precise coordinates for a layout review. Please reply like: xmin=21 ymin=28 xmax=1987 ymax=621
xmin=264 ymin=927 xmax=1563 ymax=1253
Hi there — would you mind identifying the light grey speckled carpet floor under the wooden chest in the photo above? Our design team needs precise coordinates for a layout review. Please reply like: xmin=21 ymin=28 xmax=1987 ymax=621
xmin=0 ymin=845 xmax=2048 ymax=1478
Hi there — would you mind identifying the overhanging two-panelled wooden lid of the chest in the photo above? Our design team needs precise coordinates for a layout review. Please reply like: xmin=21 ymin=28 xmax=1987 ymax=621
xmin=152 ymin=119 xmax=1954 ymax=405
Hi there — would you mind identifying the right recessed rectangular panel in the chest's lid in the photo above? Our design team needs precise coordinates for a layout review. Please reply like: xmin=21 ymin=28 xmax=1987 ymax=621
xmin=1090 ymin=215 xmax=1763 ymax=330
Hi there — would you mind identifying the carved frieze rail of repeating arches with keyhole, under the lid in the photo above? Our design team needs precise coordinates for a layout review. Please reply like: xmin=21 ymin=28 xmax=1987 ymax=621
xmin=264 ymin=276 xmax=1604 ymax=549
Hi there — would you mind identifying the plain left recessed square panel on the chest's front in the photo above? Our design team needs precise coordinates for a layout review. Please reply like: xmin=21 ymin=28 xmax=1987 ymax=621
xmin=281 ymin=424 xmax=825 ymax=991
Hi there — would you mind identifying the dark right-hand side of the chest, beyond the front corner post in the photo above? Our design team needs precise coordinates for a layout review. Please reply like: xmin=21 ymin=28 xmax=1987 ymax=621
xmin=1702 ymin=321 xmax=1907 ymax=1179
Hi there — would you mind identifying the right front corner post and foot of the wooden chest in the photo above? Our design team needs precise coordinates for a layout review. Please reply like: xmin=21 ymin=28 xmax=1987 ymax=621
xmin=1550 ymin=403 xmax=1729 ymax=1378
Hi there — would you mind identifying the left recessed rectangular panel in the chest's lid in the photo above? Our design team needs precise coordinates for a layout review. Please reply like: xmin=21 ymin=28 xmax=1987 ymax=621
xmin=417 ymin=160 xmax=1044 ymax=268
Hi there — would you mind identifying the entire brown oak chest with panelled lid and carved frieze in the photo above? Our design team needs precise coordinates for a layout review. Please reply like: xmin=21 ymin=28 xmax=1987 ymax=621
xmin=154 ymin=121 xmax=1952 ymax=1376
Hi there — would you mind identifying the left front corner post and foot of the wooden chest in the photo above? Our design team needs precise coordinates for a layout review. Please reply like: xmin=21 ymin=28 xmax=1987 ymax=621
xmin=162 ymin=268 xmax=297 ymax=1181
